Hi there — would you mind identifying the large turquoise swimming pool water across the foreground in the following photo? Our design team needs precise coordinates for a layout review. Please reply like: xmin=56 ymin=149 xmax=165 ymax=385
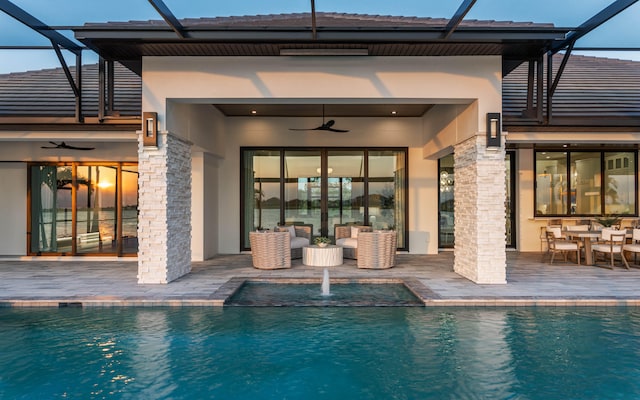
xmin=0 ymin=307 xmax=640 ymax=400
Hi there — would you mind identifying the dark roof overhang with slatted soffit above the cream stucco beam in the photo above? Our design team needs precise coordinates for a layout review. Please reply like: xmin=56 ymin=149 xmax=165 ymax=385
xmin=74 ymin=20 xmax=570 ymax=74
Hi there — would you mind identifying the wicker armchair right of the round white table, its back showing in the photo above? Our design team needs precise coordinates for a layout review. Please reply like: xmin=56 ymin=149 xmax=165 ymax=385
xmin=358 ymin=231 xmax=398 ymax=269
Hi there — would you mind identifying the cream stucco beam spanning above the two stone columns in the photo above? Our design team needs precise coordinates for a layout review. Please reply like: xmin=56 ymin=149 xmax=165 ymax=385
xmin=142 ymin=56 xmax=502 ymax=135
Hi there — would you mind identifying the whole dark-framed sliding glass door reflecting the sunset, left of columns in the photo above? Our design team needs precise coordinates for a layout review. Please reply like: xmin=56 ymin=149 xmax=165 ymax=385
xmin=29 ymin=163 xmax=138 ymax=255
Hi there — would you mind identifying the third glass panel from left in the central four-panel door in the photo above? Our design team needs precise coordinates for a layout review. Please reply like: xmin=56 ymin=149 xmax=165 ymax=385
xmin=327 ymin=150 xmax=364 ymax=239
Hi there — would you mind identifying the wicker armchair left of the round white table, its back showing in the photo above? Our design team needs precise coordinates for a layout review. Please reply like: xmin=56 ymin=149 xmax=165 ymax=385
xmin=249 ymin=232 xmax=291 ymax=269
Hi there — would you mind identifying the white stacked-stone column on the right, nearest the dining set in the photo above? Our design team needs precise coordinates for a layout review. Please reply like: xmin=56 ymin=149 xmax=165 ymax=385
xmin=453 ymin=133 xmax=506 ymax=284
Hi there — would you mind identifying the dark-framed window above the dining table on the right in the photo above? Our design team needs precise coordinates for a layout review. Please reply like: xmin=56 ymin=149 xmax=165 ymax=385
xmin=535 ymin=151 xmax=637 ymax=216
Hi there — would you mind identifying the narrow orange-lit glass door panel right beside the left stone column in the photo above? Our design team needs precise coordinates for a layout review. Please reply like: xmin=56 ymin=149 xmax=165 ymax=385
xmin=122 ymin=165 xmax=138 ymax=254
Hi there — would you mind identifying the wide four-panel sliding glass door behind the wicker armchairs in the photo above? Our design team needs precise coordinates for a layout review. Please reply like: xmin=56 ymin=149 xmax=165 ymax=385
xmin=241 ymin=148 xmax=407 ymax=250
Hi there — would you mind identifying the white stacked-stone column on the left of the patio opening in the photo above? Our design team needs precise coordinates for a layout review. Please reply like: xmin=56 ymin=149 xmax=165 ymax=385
xmin=138 ymin=133 xmax=191 ymax=283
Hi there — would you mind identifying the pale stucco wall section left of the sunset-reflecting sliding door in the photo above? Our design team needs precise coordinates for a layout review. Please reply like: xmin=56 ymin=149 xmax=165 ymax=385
xmin=0 ymin=162 xmax=27 ymax=256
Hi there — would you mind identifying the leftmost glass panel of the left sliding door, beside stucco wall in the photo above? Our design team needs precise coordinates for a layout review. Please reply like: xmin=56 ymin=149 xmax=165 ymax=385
xmin=31 ymin=165 xmax=73 ymax=254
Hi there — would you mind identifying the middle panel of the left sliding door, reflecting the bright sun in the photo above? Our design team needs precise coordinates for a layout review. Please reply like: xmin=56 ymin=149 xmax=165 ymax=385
xmin=76 ymin=166 xmax=118 ymax=254
